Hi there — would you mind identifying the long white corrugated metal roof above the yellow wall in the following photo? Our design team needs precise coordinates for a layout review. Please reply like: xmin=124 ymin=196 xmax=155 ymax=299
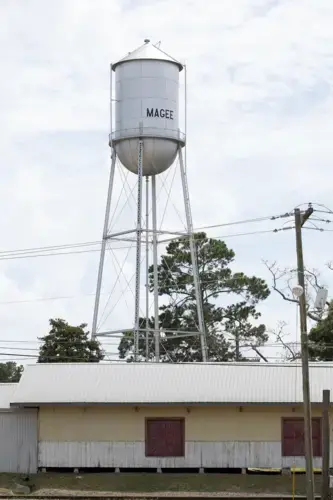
xmin=11 ymin=363 xmax=333 ymax=405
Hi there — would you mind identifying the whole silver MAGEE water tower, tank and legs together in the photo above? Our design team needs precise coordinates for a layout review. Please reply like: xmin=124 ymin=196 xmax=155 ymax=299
xmin=92 ymin=40 xmax=207 ymax=362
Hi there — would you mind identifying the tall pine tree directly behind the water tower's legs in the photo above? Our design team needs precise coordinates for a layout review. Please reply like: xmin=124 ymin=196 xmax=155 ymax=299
xmin=118 ymin=233 xmax=270 ymax=362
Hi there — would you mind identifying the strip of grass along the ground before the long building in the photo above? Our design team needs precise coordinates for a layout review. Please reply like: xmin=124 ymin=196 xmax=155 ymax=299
xmin=0 ymin=473 xmax=321 ymax=495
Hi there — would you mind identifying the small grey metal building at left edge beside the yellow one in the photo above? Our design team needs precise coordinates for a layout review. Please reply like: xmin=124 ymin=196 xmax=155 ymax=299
xmin=0 ymin=384 xmax=38 ymax=473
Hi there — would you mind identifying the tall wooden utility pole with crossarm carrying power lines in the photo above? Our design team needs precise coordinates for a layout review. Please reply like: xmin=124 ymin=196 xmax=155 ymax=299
xmin=295 ymin=205 xmax=315 ymax=500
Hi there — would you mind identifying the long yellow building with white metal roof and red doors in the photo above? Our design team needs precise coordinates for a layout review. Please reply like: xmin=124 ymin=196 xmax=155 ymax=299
xmin=5 ymin=363 xmax=333 ymax=469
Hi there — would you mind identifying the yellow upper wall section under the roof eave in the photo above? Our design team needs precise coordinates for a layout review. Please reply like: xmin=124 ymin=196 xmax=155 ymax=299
xmin=39 ymin=406 xmax=326 ymax=442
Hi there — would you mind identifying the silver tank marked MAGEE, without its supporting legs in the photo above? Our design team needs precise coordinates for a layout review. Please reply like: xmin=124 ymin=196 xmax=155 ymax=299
xmin=111 ymin=40 xmax=185 ymax=176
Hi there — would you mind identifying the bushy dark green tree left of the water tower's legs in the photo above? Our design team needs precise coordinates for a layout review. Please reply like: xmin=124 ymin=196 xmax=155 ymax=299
xmin=37 ymin=319 xmax=104 ymax=363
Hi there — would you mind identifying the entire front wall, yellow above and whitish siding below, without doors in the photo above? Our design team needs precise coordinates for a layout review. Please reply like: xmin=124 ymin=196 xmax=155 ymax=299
xmin=38 ymin=405 xmax=333 ymax=468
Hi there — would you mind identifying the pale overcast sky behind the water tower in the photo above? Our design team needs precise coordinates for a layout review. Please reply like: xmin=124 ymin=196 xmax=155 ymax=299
xmin=0 ymin=0 xmax=333 ymax=362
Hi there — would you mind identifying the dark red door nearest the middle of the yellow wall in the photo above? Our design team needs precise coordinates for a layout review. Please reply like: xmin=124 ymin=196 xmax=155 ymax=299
xmin=146 ymin=418 xmax=185 ymax=457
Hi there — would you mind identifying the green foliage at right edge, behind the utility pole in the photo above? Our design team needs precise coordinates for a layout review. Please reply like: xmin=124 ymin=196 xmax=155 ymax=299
xmin=309 ymin=301 xmax=333 ymax=361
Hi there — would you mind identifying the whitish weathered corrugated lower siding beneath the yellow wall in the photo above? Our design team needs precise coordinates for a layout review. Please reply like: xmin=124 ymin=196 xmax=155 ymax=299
xmin=38 ymin=441 xmax=333 ymax=468
